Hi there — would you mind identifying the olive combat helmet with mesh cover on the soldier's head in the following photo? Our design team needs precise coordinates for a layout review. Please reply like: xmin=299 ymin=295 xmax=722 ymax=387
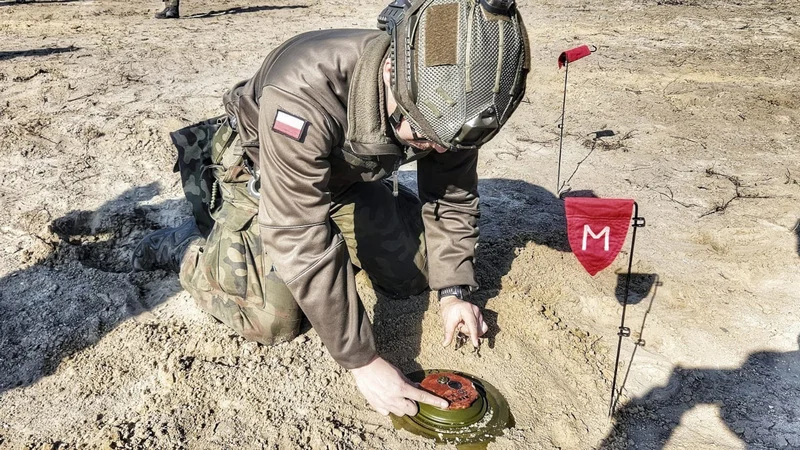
xmin=378 ymin=0 xmax=530 ymax=151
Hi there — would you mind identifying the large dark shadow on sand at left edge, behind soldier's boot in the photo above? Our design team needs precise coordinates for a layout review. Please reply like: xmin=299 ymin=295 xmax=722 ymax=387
xmin=0 ymin=185 xmax=186 ymax=394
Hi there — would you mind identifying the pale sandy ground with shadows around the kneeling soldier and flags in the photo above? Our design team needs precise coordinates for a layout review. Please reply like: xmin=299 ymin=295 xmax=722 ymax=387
xmin=0 ymin=0 xmax=800 ymax=449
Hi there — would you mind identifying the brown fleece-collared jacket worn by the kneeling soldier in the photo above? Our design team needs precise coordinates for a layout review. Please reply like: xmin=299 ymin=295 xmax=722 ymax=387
xmin=224 ymin=30 xmax=479 ymax=369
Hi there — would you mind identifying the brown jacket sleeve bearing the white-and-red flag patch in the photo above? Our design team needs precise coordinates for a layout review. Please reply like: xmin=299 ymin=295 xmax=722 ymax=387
xmin=258 ymin=86 xmax=377 ymax=369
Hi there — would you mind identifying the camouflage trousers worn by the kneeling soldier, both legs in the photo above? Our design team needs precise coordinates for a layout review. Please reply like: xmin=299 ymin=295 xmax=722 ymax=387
xmin=172 ymin=119 xmax=428 ymax=345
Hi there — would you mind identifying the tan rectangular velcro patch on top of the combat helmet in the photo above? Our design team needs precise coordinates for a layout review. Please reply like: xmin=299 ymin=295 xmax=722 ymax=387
xmin=425 ymin=3 xmax=459 ymax=67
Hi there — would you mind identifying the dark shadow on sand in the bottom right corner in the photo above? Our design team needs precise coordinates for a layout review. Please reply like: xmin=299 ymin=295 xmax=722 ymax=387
xmin=601 ymin=338 xmax=800 ymax=450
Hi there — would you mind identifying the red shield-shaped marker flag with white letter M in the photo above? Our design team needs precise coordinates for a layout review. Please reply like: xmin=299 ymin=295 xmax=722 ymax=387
xmin=564 ymin=197 xmax=633 ymax=276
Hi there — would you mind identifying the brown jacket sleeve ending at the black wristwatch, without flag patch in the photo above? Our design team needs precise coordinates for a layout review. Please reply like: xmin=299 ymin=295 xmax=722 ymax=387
xmin=417 ymin=150 xmax=480 ymax=290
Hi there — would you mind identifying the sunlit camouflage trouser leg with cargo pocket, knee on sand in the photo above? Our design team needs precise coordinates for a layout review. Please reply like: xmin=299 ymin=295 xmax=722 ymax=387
xmin=181 ymin=119 xmax=302 ymax=344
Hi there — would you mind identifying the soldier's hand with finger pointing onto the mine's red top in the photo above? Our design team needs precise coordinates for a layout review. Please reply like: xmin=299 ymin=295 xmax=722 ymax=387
xmin=350 ymin=356 xmax=448 ymax=416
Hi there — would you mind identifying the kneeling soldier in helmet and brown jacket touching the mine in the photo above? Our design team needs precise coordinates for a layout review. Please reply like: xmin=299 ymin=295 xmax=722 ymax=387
xmin=133 ymin=0 xmax=529 ymax=415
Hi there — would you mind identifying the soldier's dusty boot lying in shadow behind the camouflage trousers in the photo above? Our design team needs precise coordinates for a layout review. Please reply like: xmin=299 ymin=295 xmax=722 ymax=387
xmin=131 ymin=219 xmax=203 ymax=273
